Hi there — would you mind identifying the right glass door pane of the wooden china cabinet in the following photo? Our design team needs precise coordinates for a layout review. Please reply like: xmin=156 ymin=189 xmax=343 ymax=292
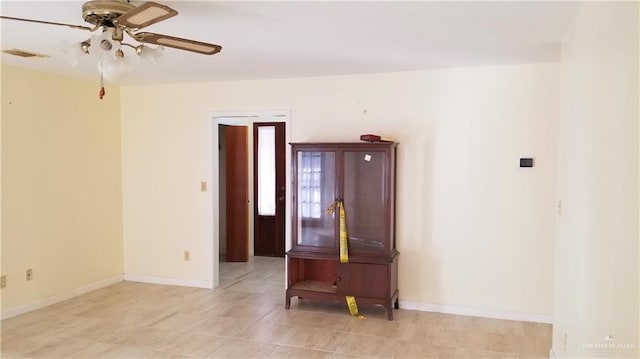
xmin=344 ymin=151 xmax=385 ymax=252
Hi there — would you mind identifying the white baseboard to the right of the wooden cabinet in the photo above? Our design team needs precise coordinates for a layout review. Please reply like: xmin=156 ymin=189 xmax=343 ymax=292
xmin=399 ymin=300 xmax=553 ymax=324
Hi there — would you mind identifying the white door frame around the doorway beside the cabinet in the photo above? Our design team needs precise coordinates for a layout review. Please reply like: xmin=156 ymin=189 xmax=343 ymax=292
xmin=208 ymin=110 xmax=291 ymax=288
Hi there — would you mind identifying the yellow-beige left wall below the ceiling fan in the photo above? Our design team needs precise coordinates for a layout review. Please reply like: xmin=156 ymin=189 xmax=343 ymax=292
xmin=2 ymin=65 xmax=123 ymax=315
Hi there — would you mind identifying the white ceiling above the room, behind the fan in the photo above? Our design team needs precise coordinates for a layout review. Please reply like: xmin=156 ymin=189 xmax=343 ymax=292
xmin=0 ymin=0 xmax=581 ymax=84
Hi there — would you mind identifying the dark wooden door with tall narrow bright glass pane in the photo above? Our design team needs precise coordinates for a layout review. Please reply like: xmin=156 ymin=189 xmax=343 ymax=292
xmin=253 ymin=122 xmax=286 ymax=257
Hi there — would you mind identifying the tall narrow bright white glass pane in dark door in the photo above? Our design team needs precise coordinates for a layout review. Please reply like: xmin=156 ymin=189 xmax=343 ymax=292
xmin=258 ymin=126 xmax=276 ymax=216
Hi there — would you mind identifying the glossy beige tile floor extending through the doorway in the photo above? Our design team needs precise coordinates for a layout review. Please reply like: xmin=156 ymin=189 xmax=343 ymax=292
xmin=1 ymin=257 xmax=551 ymax=358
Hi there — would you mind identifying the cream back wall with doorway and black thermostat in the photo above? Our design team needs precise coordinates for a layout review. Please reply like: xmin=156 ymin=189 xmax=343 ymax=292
xmin=121 ymin=64 xmax=559 ymax=320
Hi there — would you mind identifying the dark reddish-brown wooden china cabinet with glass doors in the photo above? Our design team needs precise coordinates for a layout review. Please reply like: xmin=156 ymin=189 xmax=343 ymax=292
xmin=286 ymin=142 xmax=399 ymax=320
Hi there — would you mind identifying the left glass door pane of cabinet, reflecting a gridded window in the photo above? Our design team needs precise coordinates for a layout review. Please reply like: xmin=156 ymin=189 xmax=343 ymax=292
xmin=297 ymin=152 xmax=336 ymax=248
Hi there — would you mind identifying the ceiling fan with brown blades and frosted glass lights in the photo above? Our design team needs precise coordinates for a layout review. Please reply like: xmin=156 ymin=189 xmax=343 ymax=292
xmin=0 ymin=0 xmax=222 ymax=98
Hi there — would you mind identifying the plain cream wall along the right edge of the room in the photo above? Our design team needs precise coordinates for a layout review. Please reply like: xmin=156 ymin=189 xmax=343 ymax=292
xmin=553 ymin=2 xmax=640 ymax=358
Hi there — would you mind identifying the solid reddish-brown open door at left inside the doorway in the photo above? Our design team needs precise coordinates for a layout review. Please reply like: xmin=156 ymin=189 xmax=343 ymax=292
xmin=224 ymin=126 xmax=249 ymax=262
